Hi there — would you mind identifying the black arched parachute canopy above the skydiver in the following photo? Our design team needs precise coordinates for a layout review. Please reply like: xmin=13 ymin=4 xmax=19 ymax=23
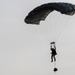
xmin=24 ymin=2 xmax=75 ymax=24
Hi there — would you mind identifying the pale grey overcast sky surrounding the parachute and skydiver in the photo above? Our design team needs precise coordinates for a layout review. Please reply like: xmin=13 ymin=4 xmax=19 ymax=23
xmin=0 ymin=0 xmax=75 ymax=75
